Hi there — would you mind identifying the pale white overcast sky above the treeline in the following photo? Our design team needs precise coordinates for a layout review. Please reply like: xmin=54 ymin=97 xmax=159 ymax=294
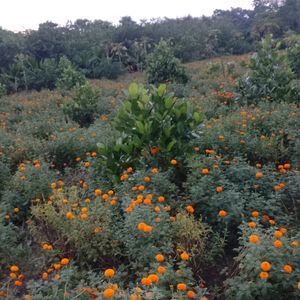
xmin=0 ymin=0 xmax=252 ymax=31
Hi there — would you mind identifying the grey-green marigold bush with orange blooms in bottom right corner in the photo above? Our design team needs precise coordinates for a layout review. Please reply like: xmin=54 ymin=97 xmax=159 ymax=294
xmin=226 ymin=221 xmax=300 ymax=300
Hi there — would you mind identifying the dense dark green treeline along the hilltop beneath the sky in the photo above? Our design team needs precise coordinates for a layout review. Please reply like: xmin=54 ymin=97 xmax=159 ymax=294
xmin=0 ymin=0 xmax=300 ymax=90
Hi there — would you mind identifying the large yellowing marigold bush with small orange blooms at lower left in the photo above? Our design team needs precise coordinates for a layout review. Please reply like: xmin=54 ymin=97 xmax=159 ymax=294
xmin=29 ymin=187 xmax=119 ymax=268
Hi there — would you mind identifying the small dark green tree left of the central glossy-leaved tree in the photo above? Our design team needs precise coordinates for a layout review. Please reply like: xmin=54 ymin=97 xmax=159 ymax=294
xmin=63 ymin=83 xmax=99 ymax=127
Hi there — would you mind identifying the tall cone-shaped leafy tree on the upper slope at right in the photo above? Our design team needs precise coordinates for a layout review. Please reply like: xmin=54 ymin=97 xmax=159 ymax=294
xmin=238 ymin=36 xmax=299 ymax=103
